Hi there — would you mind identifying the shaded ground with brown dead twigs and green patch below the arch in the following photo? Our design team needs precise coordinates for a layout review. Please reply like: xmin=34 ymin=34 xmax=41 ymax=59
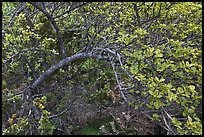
xmin=50 ymin=91 xmax=163 ymax=135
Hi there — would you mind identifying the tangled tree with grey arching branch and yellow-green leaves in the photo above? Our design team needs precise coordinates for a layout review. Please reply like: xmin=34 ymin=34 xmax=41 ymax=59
xmin=2 ymin=2 xmax=202 ymax=134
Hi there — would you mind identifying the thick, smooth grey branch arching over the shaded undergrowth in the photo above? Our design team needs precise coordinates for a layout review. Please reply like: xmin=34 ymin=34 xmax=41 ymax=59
xmin=31 ymin=53 xmax=104 ymax=88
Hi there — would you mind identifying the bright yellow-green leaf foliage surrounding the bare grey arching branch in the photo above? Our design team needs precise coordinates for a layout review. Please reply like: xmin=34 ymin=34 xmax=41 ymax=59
xmin=2 ymin=2 xmax=202 ymax=135
